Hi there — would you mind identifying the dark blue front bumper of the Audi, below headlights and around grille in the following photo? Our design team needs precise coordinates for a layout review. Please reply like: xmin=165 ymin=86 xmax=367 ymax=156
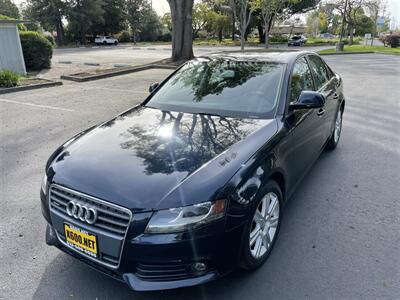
xmin=42 ymin=190 xmax=244 ymax=291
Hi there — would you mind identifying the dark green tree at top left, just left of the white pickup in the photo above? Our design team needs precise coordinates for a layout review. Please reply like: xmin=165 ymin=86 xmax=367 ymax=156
xmin=67 ymin=0 xmax=105 ymax=44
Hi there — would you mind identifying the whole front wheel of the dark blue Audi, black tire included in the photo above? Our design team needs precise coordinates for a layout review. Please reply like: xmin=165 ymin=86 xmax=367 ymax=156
xmin=239 ymin=180 xmax=283 ymax=270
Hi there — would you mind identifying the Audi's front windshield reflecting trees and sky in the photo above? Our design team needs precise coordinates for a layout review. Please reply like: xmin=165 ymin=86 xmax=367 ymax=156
xmin=147 ymin=59 xmax=285 ymax=118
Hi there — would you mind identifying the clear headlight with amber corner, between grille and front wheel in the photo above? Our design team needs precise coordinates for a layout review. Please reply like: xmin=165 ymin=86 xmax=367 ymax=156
xmin=145 ymin=200 xmax=226 ymax=233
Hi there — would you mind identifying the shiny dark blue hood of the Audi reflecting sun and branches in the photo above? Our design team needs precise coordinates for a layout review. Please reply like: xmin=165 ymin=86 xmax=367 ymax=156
xmin=48 ymin=107 xmax=272 ymax=211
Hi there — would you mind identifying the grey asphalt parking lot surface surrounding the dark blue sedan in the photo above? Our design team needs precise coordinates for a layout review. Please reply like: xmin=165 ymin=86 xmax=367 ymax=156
xmin=0 ymin=50 xmax=400 ymax=300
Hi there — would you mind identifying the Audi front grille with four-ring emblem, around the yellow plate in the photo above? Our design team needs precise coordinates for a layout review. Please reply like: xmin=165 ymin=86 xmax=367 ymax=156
xmin=49 ymin=184 xmax=132 ymax=269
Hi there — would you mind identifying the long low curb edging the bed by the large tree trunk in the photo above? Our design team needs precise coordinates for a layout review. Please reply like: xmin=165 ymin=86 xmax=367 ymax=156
xmin=60 ymin=64 xmax=177 ymax=82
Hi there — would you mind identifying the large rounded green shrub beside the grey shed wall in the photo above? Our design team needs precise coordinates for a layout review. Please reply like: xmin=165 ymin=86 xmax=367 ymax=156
xmin=20 ymin=31 xmax=53 ymax=70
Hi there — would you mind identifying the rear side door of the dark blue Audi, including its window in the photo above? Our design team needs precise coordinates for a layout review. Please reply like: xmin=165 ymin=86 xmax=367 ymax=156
xmin=308 ymin=55 xmax=339 ymax=142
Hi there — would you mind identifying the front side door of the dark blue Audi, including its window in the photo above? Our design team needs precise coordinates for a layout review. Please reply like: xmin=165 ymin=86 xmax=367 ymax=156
xmin=285 ymin=56 xmax=324 ymax=181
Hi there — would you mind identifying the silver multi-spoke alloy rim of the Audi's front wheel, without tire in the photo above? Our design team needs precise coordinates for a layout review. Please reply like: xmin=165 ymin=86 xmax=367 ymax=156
xmin=249 ymin=192 xmax=279 ymax=259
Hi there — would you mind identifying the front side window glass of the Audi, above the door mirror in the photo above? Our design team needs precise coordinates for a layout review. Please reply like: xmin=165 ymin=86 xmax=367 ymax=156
xmin=289 ymin=57 xmax=314 ymax=102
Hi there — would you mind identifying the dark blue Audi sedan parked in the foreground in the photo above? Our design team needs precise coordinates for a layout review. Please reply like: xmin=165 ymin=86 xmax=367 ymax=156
xmin=40 ymin=52 xmax=345 ymax=291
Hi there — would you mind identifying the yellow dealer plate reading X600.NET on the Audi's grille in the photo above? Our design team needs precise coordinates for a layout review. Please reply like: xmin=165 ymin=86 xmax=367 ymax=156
xmin=64 ymin=223 xmax=97 ymax=257
